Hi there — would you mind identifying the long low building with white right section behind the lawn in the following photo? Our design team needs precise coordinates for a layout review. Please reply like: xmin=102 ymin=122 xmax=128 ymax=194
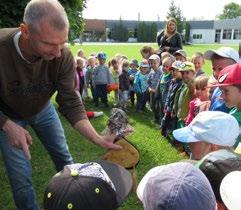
xmin=82 ymin=17 xmax=241 ymax=44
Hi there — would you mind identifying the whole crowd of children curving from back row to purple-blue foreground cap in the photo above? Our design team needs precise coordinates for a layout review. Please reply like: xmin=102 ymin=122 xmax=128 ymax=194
xmin=64 ymin=47 xmax=241 ymax=210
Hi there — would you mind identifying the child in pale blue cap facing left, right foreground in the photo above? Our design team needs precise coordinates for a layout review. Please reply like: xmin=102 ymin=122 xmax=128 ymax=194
xmin=173 ymin=111 xmax=239 ymax=160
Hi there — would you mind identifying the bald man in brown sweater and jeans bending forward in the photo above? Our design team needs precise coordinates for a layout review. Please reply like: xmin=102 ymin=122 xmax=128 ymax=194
xmin=0 ymin=0 xmax=120 ymax=210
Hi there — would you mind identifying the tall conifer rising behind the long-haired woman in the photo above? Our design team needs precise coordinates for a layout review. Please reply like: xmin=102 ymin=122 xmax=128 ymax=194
xmin=166 ymin=0 xmax=185 ymax=33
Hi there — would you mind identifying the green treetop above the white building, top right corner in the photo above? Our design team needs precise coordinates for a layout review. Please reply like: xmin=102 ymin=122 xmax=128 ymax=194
xmin=218 ymin=2 xmax=241 ymax=20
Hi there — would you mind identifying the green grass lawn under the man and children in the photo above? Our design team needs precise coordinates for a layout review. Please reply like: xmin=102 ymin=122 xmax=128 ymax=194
xmin=0 ymin=44 xmax=238 ymax=210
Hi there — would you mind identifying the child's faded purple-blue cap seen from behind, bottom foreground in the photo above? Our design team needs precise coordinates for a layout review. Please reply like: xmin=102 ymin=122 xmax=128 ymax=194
xmin=136 ymin=162 xmax=216 ymax=210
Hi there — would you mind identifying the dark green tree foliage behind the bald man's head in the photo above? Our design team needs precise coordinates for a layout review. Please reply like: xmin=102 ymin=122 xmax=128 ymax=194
xmin=0 ymin=0 xmax=86 ymax=40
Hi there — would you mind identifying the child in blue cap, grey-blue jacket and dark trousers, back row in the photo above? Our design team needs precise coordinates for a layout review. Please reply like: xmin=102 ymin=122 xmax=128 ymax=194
xmin=93 ymin=52 xmax=111 ymax=107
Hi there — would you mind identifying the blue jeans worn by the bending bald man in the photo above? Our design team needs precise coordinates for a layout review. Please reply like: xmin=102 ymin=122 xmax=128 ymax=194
xmin=0 ymin=103 xmax=73 ymax=210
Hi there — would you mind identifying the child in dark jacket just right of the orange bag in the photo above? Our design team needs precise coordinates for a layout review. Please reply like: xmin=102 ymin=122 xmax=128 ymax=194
xmin=119 ymin=61 xmax=130 ymax=111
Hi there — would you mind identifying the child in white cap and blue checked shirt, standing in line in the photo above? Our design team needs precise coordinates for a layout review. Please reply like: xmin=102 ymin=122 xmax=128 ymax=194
xmin=147 ymin=54 xmax=162 ymax=124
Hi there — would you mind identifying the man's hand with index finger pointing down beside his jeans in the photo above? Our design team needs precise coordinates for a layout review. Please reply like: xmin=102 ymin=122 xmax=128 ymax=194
xmin=3 ymin=120 xmax=32 ymax=160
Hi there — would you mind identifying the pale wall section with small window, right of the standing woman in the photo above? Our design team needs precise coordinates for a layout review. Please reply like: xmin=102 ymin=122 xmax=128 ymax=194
xmin=190 ymin=29 xmax=215 ymax=44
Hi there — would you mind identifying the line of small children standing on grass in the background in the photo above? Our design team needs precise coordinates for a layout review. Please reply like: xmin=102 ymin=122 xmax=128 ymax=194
xmin=73 ymin=46 xmax=241 ymax=157
